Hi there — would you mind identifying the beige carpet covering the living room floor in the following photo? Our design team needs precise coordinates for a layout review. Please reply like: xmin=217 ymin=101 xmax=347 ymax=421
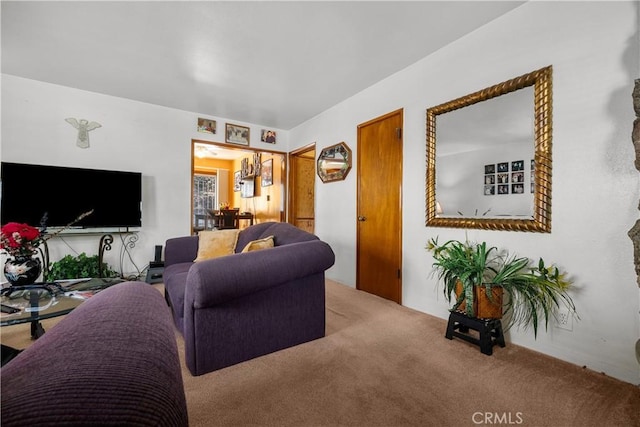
xmin=2 ymin=281 xmax=640 ymax=427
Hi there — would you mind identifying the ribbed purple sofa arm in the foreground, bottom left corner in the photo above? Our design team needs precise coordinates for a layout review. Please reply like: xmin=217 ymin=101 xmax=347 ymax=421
xmin=0 ymin=282 xmax=188 ymax=427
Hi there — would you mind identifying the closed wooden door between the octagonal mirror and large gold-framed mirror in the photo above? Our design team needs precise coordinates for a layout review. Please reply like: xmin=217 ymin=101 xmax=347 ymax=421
xmin=356 ymin=110 xmax=402 ymax=304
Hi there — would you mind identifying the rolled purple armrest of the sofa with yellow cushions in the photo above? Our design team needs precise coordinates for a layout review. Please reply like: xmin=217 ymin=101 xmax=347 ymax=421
xmin=185 ymin=240 xmax=335 ymax=309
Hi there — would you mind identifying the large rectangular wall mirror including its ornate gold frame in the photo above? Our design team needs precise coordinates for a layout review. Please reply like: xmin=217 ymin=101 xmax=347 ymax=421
xmin=426 ymin=66 xmax=552 ymax=233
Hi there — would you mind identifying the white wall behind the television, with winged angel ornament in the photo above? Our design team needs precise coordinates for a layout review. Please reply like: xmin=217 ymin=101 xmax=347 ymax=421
xmin=0 ymin=74 xmax=288 ymax=280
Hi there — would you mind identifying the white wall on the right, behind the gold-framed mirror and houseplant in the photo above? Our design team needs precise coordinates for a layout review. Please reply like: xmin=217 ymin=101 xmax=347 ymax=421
xmin=289 ymin=2 xmax=640 ymax=384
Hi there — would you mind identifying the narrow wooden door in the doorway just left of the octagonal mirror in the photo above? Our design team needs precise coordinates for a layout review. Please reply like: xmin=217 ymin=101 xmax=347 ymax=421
xmin=289 ymin=144 xmax=316 ymax=233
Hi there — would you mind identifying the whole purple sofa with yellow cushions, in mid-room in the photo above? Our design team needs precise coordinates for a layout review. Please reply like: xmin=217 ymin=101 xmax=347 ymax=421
xmin=163 ymin=222 xmax=335 ymax=375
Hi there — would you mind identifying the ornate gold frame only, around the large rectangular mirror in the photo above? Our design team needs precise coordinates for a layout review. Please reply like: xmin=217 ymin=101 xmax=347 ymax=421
xmin=425 ymin=65 xmax=553 ymax=233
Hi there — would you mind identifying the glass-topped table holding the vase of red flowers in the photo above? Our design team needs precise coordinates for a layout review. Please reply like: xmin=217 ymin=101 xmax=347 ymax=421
xmin=0 ymin=278 xmax=123 ymax=339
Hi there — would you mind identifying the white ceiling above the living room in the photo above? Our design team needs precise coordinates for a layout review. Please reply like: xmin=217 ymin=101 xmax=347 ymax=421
xmin=1 ymin=0 xmax=524 ymax=130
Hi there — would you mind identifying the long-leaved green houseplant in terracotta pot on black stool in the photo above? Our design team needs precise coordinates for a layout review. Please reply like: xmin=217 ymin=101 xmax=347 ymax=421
xmin=426 ymin=238 xmax=576 ymax=337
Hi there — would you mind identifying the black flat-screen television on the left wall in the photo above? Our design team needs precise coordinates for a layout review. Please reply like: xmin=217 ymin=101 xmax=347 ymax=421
xmin=0 ymin=162 xmax=142 ymax=228
